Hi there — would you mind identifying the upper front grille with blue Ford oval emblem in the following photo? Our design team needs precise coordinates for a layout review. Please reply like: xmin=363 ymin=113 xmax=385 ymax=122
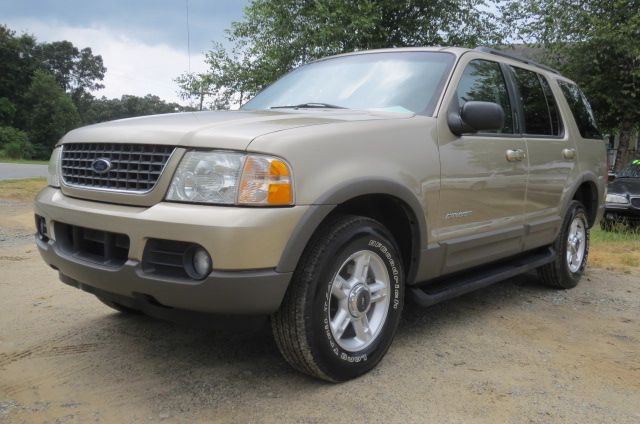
xmin=62 ymin=143 xmax=174 ymax=193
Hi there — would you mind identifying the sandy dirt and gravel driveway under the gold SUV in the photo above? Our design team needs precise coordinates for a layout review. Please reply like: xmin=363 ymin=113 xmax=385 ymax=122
xmin=0 ymin=196 xmax=640 ymax=424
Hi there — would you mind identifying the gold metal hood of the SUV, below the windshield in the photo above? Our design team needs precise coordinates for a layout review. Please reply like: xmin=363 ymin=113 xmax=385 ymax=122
xmin=58 ymin=109 xmax=413 ymax=150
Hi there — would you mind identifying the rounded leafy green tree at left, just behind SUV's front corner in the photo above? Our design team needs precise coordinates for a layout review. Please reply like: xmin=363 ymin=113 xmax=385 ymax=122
xmin=25 ymin=70 xmax=80 ymax=159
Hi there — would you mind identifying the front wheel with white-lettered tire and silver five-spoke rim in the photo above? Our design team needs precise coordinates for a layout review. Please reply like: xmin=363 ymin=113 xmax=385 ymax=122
xmin=271 ymin=216 xmax=404 ymax=382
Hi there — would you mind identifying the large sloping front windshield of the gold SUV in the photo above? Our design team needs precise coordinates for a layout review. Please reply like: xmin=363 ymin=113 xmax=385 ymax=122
xmin=242 ymin=51 xmax=455 ymax=115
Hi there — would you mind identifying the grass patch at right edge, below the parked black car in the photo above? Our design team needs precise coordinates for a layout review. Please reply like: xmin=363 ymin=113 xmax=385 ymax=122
xmin=589 ymin=226 xmax=640 ymax=274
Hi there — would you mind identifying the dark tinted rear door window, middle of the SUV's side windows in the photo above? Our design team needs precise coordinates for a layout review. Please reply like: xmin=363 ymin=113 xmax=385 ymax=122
xmin=511 ymin=66 xmax=562 ymax=136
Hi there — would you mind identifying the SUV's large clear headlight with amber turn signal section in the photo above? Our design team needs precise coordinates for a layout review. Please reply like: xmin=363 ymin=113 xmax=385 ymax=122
xmin=167 ymin=151 xmax=293 ymax=206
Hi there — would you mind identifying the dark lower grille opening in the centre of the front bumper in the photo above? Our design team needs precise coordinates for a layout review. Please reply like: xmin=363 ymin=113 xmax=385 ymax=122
xmin=54 ymin=222 xmax=129 ymax=267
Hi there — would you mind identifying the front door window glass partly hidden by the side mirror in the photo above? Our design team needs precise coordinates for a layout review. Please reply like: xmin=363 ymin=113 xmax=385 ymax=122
xmin=457 ymin=60 xmax=513 ymax=134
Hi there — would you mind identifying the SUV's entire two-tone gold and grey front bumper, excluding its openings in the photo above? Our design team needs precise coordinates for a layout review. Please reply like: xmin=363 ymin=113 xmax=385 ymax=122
xmin=35 ymin=188 xmax=308 ymax=314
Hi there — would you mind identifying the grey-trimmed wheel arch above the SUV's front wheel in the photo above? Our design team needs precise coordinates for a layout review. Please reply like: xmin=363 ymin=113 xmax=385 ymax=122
xmin=276 ymin=179 xmax=426 ymax=282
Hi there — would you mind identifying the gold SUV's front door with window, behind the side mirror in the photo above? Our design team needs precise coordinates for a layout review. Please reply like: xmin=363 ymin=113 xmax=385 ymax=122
xmin=436 ymin=53 xmax=527 ymax=273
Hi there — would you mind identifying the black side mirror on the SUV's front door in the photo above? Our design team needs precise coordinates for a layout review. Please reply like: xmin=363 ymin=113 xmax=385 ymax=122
xmin=447 ymin=101 xmax=504 ymax=135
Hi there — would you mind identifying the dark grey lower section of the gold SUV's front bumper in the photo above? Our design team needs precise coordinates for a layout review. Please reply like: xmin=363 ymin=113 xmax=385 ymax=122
xmin=36 ymin=239 xmax=291 ymax=315
